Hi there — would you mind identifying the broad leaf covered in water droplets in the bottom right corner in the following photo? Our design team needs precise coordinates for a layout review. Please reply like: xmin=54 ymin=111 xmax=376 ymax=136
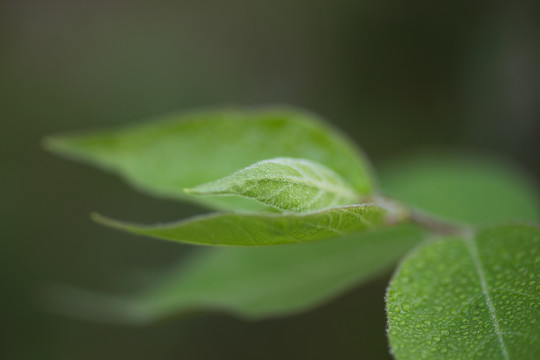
xmin=387 ymin=225 xmax=540 ymax=360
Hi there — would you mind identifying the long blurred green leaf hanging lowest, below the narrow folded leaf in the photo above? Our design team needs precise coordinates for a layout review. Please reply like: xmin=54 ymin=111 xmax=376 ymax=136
xmin=50 ymin=226 xmax=420 ymax=323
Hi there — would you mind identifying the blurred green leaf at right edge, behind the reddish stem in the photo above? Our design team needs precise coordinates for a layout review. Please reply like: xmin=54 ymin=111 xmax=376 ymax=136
xmin=381 ymin=151 xmax=540 ymax=225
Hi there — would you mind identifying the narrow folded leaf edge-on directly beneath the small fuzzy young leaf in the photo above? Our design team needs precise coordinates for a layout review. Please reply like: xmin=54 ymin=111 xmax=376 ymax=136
xmin=93 ymin=204 xmax=386 ymax=246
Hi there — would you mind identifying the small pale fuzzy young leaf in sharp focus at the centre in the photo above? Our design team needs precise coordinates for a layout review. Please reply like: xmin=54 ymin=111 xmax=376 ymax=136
xmin=186 ymin=158 xmax=360 ymax=212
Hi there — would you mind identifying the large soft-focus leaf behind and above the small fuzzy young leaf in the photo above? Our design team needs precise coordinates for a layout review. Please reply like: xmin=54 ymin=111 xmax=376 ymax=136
xmin=45 ymin=108 xmax=374 ymax=210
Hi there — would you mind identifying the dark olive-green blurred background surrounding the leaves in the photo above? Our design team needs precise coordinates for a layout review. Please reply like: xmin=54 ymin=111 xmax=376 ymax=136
xmin=0 ymin=0 xmax=540 ymax=360
